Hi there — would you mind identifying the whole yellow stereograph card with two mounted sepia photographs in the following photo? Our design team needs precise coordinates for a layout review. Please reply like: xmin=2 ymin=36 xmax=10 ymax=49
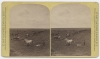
xmin=2 ymin=2 xmax=99 ymax=57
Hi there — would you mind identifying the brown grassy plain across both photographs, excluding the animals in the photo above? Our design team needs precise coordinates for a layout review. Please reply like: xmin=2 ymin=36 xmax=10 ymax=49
xmin=10 ymin=28 xmax=91 ymax=56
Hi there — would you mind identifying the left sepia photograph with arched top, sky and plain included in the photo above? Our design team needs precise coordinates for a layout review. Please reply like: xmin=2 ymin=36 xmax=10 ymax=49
xmin=10 ymin=4 xmax=50 ymax=56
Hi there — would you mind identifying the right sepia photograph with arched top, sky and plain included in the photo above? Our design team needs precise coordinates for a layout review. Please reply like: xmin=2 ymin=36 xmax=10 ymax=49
xmin=51 ymin=4 xmax=91 ymax=56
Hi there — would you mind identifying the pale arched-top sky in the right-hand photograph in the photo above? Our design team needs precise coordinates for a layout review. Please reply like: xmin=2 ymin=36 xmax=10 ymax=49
xmin=51 ymin=4 xmax=91 ymax=28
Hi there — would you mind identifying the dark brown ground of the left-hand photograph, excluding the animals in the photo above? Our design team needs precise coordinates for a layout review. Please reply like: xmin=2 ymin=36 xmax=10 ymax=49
xmin=10 ymin=29 xmax=50 ymax=56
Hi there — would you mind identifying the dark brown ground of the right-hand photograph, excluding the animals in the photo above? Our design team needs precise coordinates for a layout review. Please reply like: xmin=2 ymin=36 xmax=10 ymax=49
xmin=51 ymin=28 xmax=91 ymax=56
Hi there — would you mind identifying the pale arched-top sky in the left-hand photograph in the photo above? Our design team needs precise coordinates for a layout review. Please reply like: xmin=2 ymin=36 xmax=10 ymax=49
xmin=10 ymin=4 xmax=50 ymax=28
